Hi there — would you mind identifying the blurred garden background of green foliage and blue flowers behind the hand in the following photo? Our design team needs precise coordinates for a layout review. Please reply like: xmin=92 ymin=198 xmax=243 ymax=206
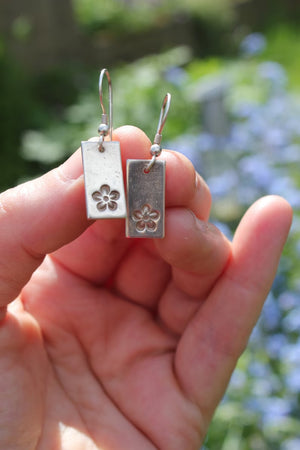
xmin=0 ymin=0 xmax=300 ymax=450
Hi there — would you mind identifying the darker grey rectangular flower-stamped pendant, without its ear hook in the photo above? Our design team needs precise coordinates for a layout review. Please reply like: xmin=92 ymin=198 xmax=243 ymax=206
xmin=126 ymin=159 xmax=166 ymax=238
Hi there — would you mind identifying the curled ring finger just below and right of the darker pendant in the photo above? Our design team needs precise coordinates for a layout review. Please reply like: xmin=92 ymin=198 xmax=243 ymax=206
xmin=156 ymin=208 xmax=231 ymax=335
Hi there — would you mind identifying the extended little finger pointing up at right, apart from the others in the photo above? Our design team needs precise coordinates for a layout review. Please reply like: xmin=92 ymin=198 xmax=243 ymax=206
xmin=175 ymin=196 xmax=292 ymax=424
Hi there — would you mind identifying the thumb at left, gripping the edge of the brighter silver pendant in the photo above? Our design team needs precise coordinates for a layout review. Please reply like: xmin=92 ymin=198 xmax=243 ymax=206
xmin=0 ymin=151 xmax=89 ymax=312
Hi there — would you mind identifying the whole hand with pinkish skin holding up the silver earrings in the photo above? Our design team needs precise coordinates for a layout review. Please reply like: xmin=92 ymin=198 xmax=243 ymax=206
xmin=0 ymin=127 xmax=292 ymax=450
